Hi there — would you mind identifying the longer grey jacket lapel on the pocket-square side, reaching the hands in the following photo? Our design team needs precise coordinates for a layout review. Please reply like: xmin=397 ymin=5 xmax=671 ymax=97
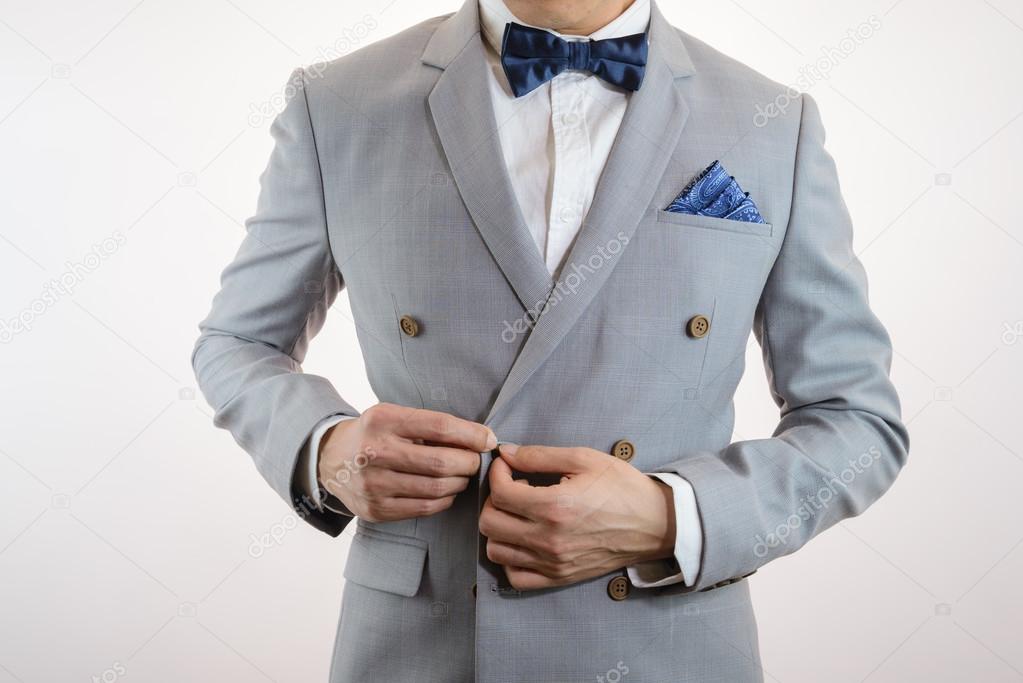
xmin=487 ymin=6 xmax=693 ymax=421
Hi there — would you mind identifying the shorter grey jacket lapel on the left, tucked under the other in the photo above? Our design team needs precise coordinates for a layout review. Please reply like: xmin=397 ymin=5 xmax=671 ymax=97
xmin=422 ymin=0 xmax=553 ymax=313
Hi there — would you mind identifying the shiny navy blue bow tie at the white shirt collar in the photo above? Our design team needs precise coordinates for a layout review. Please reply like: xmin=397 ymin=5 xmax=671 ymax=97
xmin=501 ymin=21 xmax=647 ymax=97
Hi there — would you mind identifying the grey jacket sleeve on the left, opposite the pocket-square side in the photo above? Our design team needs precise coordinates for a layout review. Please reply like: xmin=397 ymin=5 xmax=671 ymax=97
xmin=192 ymin=70 xmax=358 ymax=536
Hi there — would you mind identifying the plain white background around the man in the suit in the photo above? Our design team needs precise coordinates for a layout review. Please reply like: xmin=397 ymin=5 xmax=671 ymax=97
xmin=0 ymin=0 xmax=1023 ymax=683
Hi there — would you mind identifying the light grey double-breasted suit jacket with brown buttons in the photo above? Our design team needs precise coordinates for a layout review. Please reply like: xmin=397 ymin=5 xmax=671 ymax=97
xmin=193 ymin=0 xmax=907 ymax=683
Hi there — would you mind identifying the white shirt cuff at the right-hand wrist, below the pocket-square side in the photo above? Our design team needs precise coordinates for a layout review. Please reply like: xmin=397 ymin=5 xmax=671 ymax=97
xmin=626 ymin=472 xmax=703 ymax=588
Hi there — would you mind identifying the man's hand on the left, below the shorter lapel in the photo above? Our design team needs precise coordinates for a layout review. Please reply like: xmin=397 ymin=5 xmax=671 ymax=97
xmin=318 ymin=403 xmax=497 ymax=521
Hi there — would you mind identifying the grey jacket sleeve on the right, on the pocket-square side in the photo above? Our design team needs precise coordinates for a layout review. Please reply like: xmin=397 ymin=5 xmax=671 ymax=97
xmin=662 ymin=95 xmax=908 ymax=590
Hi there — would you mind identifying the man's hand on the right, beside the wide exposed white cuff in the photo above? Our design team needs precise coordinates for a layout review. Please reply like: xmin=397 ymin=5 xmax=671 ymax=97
xmin=480 ymin=444 xmax=675 ymax=590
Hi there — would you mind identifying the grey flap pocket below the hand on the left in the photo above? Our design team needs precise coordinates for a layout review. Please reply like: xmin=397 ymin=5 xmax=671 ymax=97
xmin=345 ymin=525 xmax=427 ymax=597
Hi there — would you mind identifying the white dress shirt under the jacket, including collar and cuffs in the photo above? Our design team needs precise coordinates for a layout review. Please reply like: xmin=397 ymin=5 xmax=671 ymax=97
xmin=299 ymin=0 xmax=703 ymax=588
